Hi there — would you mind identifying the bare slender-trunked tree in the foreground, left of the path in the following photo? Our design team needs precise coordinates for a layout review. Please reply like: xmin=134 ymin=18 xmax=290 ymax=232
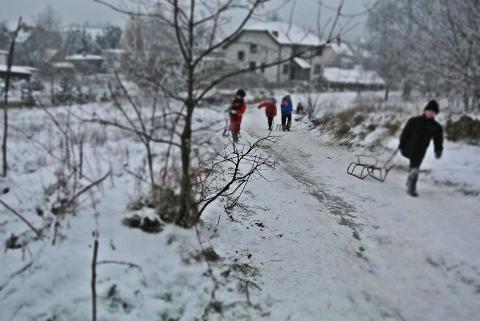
xmin=94 ymin=0 xmax=343 ymax=227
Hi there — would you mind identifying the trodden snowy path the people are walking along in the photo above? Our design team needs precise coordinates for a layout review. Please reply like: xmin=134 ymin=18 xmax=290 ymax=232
xmin=210 ymin=111 xmax=480 ymax=321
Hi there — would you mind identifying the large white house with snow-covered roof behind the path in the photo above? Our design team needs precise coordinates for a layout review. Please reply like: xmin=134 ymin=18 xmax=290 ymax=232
xmin=223 ymin=22 xmax=351 ymax=83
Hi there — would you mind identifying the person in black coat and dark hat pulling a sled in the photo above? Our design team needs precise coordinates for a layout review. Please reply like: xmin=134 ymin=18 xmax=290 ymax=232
xmin=399 ymin=100 xmax=443 ymax=197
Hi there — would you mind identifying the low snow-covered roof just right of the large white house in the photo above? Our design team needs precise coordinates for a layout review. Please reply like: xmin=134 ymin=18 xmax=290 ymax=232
xmin=323 ymin=66 xmax=385 ymax=85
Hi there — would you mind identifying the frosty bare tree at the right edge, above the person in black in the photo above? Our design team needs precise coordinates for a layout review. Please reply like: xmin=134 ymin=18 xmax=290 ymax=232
xmin=411 ymin=0 xmax=480 ymax=111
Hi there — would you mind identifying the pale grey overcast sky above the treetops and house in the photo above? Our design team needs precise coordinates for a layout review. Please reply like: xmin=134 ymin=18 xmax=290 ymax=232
xmin=0 ymin=0 xmax=375 ymax=39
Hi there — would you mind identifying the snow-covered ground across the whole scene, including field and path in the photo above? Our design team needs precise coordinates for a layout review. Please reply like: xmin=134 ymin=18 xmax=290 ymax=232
xmin=0 ymin=92 xmax=480 ymax=321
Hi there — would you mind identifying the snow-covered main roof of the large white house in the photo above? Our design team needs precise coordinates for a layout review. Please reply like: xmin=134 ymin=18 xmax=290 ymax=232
xmin=243 ymin=22 xmax=324 ymax=46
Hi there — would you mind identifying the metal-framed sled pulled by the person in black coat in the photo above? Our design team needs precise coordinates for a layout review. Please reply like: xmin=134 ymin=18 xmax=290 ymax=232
xmin=347 ymin=149 xmax=398 ymax=182
